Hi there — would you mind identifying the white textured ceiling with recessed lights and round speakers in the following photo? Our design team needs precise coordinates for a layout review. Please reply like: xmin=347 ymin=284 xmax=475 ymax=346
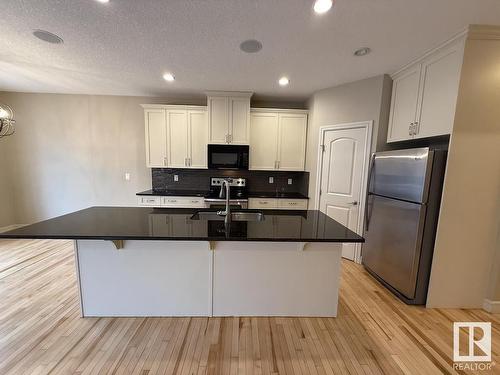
xmin=0 ymin=0 xmax=500 ymax=100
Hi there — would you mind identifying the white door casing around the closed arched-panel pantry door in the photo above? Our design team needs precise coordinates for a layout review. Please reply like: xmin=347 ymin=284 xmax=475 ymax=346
xmin=314 ymin=120 xmax=373 ymax=263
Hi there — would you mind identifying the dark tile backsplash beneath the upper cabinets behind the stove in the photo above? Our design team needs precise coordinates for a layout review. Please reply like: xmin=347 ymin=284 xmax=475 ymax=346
xmin=151 ymin=168 xmax=309 ymax=196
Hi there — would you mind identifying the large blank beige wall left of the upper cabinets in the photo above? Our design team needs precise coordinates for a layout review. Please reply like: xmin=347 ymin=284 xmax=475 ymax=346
xmin=0 ymin=92 xmax=207 ymax=226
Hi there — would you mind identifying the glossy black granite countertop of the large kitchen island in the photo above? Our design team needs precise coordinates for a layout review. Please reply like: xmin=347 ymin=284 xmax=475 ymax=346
xmin=0 ymin=207 xmax=364 ymax=242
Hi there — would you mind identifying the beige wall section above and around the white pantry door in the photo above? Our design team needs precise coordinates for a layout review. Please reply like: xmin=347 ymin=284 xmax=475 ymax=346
xmin=306 ymin=75 xmax=392 ymax=208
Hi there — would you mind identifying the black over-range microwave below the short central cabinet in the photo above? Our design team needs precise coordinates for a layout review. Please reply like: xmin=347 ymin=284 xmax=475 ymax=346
xmin=208 ymin=145 xmax=249 ymax=169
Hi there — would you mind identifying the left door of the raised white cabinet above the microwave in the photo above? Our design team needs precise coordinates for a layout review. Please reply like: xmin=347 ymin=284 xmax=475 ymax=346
xmin=207 ymin=96 xmax=229 ymax=143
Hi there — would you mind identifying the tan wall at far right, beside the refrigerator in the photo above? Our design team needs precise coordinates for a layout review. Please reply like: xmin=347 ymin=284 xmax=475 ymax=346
xmin=427 ymin=28 xmax=500 ymax=308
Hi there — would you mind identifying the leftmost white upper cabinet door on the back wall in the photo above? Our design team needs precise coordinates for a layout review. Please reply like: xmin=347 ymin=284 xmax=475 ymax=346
xmin=144 ymin=109 xmax=167 ymax=168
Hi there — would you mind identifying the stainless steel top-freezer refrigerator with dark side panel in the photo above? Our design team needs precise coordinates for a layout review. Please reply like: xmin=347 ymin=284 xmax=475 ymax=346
xmin=362 ymin=148 xmax=446 ymax=304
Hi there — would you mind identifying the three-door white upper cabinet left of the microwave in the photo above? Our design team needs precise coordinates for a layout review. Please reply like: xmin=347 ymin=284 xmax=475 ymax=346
xmin=143 ymin=105 xmax=208 ymax=168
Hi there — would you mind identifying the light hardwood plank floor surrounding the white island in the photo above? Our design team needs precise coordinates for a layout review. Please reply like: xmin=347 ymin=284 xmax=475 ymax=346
xmin=0 ymin=240 xmax=500 ymax=375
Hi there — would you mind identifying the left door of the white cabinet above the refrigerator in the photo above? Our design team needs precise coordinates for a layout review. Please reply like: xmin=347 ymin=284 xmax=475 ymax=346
xmin=387 ymin=64 xmax=420 ymax=142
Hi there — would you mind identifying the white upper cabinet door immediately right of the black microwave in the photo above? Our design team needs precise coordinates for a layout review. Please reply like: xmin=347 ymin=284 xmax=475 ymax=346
xmin=250 ymin=112 xmax=279 ymax=170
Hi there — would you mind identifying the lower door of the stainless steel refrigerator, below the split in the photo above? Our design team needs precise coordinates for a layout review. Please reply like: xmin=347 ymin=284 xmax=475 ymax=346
xmin=362 ymin=195 xmax=426 ymax=299
